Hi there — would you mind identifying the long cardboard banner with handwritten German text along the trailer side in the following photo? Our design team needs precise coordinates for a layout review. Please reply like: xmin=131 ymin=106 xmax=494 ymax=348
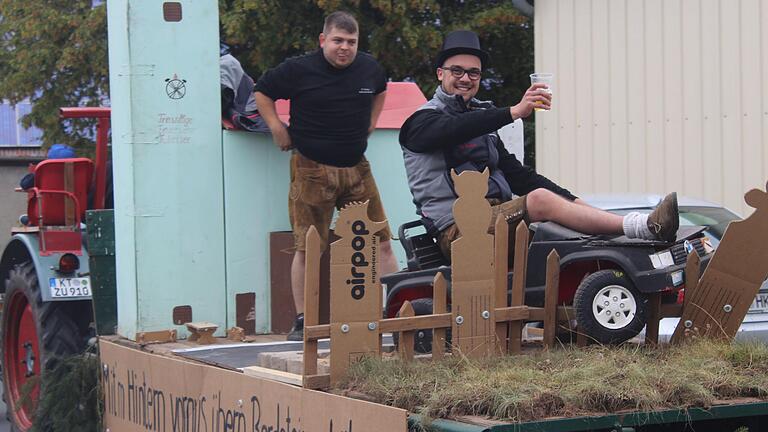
xmin=99 ymin=340 xmax=406 ymax=432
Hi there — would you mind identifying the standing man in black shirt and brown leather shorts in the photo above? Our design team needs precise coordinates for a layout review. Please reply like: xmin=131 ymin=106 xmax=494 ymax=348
xmin=256 ymin=12 xmax=398 ymax=340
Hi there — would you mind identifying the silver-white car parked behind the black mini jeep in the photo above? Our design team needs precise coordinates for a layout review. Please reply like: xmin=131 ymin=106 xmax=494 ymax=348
xmin=581 ymin=194 xmax=768 ymax=342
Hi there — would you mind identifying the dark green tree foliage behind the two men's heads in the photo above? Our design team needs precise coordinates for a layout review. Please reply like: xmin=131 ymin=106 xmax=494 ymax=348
xmin=219 ymin=0 xmax=533 ymax=105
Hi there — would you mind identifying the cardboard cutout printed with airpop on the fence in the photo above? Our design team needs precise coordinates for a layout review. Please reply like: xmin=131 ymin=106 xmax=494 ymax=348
xmin=331 ymin=201 xmax=387 ymax=383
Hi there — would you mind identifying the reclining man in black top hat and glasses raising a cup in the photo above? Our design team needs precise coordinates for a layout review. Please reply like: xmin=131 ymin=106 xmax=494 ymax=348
xmin=400 ymin=30 xmax=679 ymax=257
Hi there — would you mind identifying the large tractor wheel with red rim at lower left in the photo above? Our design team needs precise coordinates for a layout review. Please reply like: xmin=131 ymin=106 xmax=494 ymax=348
xmin=2 ymin=263 xmax=90 ymax=432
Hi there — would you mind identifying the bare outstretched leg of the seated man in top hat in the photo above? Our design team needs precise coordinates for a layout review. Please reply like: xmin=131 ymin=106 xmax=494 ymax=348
xmin=526 ymin=189 xmax=624 ymax=234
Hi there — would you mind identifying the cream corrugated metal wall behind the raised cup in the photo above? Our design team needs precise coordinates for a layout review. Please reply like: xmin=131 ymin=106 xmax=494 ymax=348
xmin=535 ymin=0 xmax=768 ymax=215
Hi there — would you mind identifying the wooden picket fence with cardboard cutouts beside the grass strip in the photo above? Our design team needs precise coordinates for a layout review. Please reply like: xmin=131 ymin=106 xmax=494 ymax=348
xmin=302 ymin=171 xmax=768 ymax=388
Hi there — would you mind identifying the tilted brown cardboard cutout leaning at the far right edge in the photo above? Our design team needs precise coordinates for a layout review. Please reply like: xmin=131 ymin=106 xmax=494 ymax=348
xmin=672 ymin=181 xmax=768 ymax=342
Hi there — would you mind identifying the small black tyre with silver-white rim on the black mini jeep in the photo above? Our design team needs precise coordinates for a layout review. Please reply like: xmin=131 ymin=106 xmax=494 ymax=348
xmin=573 ymin=270 xmax=647 ymax=344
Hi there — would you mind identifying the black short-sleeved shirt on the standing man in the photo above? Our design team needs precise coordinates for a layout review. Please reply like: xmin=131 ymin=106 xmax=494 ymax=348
xmin=256 ymin=50 xmax=387 ymax=167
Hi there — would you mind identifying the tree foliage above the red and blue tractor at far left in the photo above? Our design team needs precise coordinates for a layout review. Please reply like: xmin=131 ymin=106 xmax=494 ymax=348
xmin=0 ymin=0 xmax=109 ymax=154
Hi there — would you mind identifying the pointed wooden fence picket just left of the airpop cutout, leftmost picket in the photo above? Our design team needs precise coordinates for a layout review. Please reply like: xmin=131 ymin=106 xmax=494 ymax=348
xmin=303 ymin=225 xmax=320 ymax=375
